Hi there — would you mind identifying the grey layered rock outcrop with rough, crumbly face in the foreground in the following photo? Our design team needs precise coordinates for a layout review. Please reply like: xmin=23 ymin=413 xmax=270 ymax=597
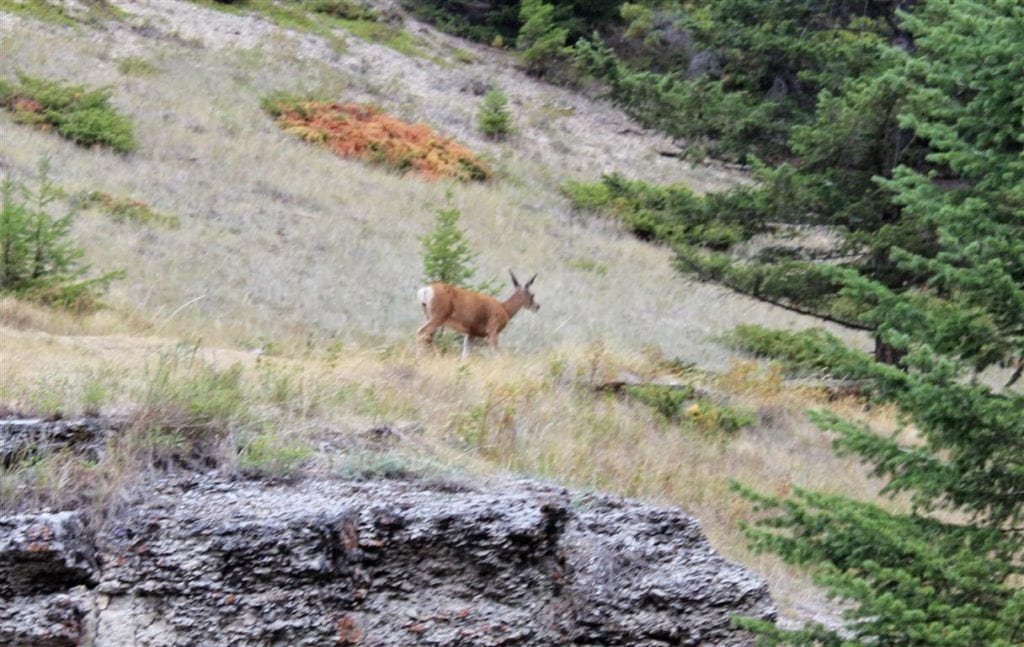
xmin=0 ymin=476 xmax=775 ymax=646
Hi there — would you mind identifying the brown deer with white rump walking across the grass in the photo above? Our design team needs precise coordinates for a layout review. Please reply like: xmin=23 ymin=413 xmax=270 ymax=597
xmin=416 ymin=269 xmax=541 ymax=359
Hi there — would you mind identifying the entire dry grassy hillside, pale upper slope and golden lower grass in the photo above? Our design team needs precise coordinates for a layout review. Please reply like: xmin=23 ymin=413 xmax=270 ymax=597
xmin=0 ymin=0 xmax=892 ymax=622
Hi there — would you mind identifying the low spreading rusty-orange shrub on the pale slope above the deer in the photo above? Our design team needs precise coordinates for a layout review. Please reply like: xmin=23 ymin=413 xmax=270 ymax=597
xmin=266 ymin=97 xmax=490 ymax=180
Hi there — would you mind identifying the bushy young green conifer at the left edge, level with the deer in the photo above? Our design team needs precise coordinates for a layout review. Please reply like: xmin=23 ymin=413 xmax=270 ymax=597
xmin=0 ymin=161 xmax=124 ymax=309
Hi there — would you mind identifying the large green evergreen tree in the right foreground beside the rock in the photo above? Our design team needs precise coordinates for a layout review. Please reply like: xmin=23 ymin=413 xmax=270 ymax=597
xmin=741 ymin=0 xmax=1024 ymax=647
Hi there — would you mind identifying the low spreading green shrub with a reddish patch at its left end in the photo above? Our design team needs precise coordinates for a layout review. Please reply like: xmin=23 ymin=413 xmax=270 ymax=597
xmin=0 ymin=75 xmax=136 ymax=153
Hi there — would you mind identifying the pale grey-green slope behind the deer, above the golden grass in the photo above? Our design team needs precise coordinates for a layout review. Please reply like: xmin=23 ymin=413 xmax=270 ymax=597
xmin=0 ymin=0 xmax=868 ymax=365
